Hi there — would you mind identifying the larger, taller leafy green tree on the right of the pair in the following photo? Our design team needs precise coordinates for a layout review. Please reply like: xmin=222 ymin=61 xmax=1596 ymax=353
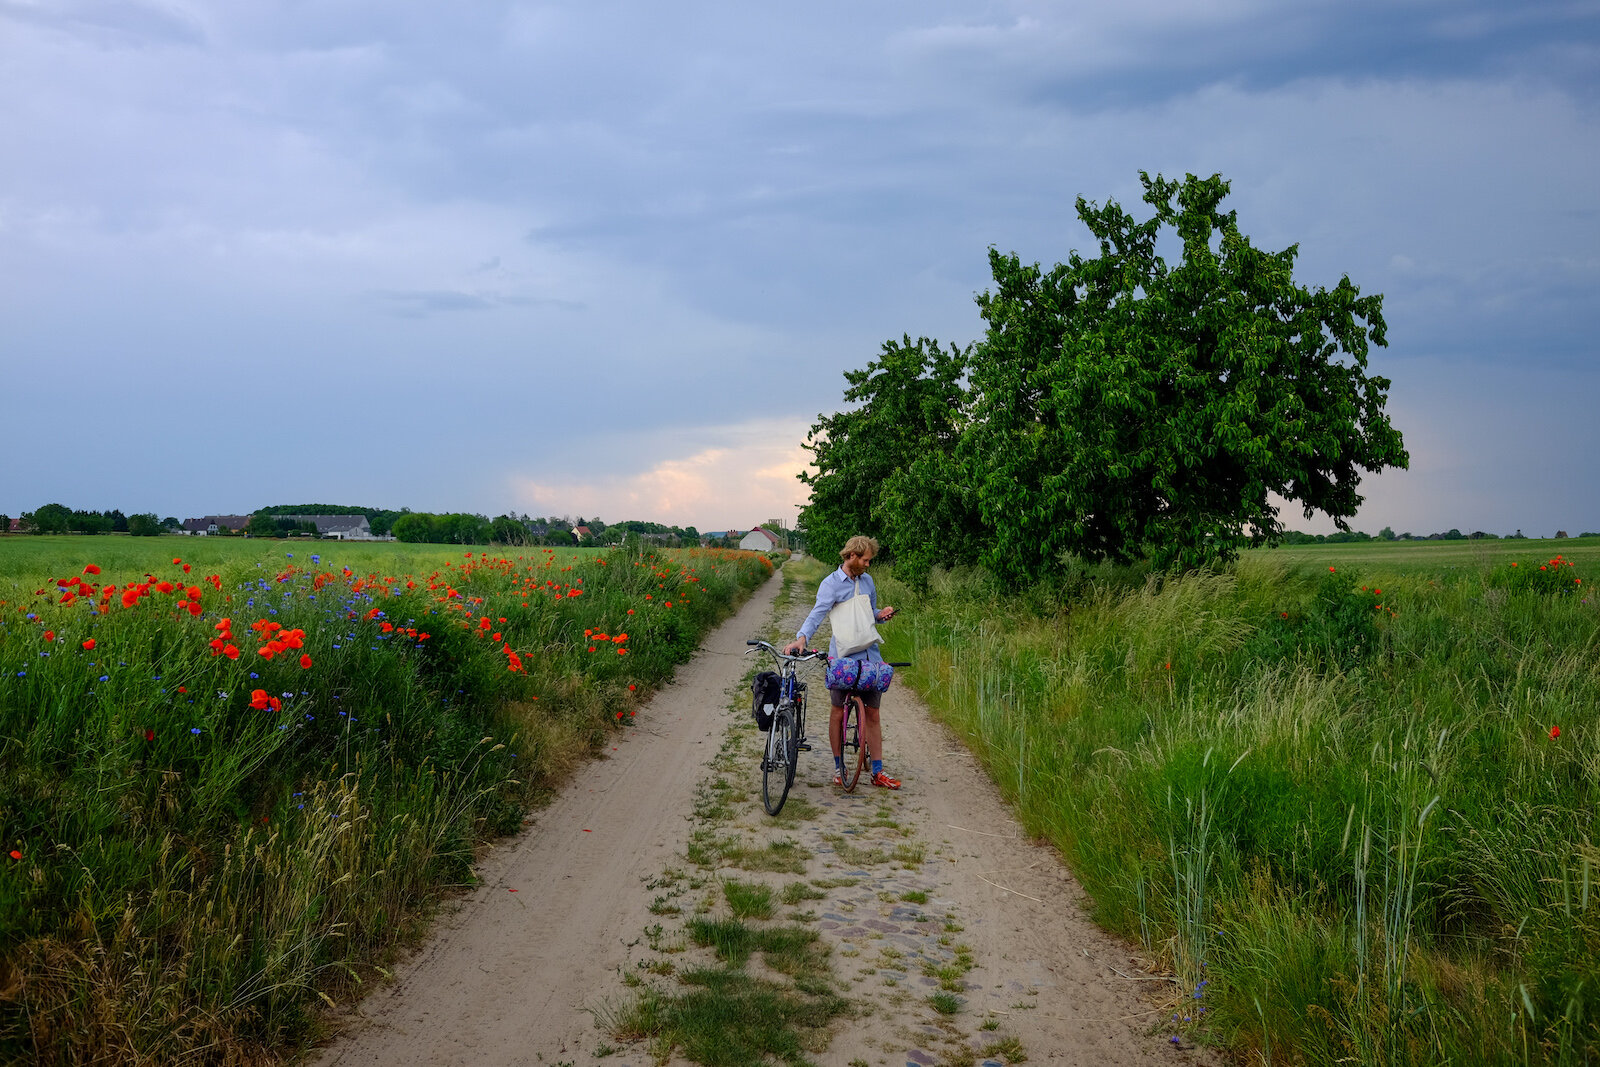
xmin=962 ymin=174 xmax=1408 ymax=577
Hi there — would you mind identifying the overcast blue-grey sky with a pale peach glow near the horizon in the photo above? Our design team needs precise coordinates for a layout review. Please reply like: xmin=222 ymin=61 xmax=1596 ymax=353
xmin=0 ymin=0 xmax=1600 ymax=536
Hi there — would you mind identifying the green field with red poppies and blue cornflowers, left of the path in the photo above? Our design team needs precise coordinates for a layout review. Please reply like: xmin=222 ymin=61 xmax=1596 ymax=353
xmin=0 ymin=537 xmax=773 ymax=1064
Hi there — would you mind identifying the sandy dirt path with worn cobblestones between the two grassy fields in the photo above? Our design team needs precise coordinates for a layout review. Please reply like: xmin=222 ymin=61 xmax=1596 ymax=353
xmin=314 ymin=577 xmax=1211 ymax=1067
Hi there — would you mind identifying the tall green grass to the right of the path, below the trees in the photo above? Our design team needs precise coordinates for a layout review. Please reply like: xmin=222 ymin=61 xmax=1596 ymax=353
xmin=880 ymin=553 xmax=1600 ymax=1064
